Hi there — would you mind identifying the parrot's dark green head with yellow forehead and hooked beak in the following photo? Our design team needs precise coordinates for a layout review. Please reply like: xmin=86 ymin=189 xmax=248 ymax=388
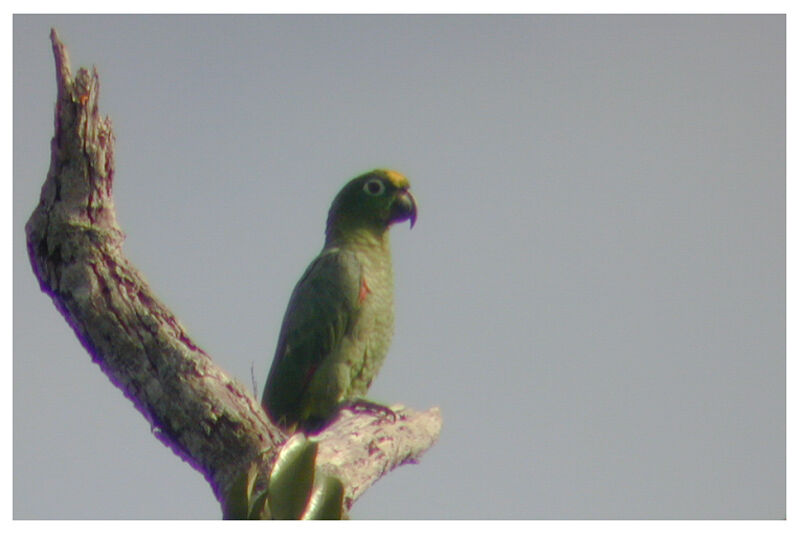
xmin=327 ymin=169 xmax=417 ymax=243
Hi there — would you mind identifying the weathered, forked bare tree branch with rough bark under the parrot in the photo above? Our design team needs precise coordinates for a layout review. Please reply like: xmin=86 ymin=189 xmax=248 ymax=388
xmin=25 ymin=31 xmax=441 ymax=520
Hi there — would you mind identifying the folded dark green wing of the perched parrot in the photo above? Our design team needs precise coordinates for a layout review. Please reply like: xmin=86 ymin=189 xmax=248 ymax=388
xmin=262 ymin=248 xmax=362 ymax=430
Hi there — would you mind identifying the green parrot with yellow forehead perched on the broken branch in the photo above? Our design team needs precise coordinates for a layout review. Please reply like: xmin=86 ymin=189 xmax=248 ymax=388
xmin=261 ymin=169 xmax=417 ymax=433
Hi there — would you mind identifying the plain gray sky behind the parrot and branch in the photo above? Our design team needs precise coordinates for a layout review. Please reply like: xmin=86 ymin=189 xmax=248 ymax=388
xmin=13 ymin=16 xmax=786 ymax=519
